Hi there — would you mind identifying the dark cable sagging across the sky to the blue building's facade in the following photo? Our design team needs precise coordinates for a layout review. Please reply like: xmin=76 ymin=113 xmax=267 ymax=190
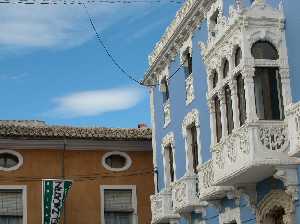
xmin=82 ymin=3 xmax=186 ymax=87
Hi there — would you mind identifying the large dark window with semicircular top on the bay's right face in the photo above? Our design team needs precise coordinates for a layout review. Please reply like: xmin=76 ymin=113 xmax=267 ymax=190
xmin=252 ymin=41 xmax=284 ymax=120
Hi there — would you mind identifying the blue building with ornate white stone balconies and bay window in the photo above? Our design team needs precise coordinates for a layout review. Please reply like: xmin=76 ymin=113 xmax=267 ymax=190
xmin=144 ymin=0 xmax=300 ymax=224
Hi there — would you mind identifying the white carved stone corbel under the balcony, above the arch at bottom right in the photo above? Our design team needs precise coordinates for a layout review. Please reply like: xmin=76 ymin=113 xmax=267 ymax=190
xmin=274 ymin=168 xmax=299 ymax=201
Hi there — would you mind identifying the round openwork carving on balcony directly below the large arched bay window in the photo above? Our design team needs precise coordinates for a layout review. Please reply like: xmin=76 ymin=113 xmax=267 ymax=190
xmin=259 ymin=127 xmax=288 ymax=152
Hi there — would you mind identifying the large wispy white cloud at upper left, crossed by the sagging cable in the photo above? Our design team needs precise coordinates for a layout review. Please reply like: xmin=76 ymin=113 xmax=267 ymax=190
xmin=0 ymin=4 xmax=137 ymax=51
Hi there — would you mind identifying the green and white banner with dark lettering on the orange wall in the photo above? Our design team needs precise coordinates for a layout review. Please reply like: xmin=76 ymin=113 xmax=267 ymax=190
xmin=43 ymin=180 xmax=72 ymax=224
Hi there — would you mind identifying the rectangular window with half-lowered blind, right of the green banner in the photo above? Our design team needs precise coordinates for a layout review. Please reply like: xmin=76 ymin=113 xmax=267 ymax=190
xmin=102 ymin=187 xmax=136 ymax=224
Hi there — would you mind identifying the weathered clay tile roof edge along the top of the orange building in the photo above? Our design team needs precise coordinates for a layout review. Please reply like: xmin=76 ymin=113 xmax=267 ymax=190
xmin=0 ymin=121 xmax=152 ymax=140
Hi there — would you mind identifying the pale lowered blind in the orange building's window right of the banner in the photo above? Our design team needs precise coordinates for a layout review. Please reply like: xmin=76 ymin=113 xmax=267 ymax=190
xmin=104 ymin=190 xmax=134 ymax=212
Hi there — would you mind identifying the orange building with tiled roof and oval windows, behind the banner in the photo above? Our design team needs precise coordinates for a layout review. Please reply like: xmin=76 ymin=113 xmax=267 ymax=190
xmin=0 ymin=121 xmax=154 ymax=224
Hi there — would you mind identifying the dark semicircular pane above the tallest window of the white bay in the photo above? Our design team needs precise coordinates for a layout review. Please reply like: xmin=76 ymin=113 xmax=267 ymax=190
xmin=251 ymin=41 xmax=279 ymax=60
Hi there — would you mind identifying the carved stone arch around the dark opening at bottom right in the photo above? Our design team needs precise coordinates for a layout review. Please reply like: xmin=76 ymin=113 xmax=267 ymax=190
xmin=256 ymin=190 xmax=295 ymax=224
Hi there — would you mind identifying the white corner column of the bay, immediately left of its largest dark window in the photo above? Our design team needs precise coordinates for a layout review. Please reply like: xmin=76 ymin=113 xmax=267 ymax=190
xmin=242 ymin=68 xmax=258 ymax=123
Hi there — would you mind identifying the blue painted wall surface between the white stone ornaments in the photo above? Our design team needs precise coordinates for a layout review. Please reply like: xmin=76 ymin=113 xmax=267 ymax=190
xmin=154 ymin=0 xmax=300 ymax=224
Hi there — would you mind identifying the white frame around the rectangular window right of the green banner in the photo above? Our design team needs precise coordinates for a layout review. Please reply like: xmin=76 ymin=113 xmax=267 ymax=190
xmin=100 ymin=185 xmax=138 ymax=224
